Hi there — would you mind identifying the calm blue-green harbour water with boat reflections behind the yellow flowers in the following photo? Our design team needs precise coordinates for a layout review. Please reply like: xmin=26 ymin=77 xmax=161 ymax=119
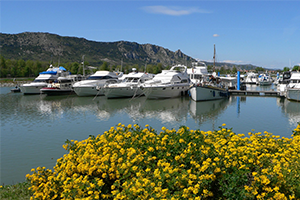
xmin=0 ymin=86 xmax=300 ymax=184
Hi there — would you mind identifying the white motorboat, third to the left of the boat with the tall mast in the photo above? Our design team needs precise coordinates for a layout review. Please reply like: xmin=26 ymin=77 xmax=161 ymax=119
xmin=73 ymin=70 xmax=120 ymax=96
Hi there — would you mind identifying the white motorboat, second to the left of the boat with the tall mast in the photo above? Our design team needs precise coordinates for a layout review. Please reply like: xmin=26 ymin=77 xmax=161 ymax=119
xmin=103 ymin=68 xmax=154 ymax=98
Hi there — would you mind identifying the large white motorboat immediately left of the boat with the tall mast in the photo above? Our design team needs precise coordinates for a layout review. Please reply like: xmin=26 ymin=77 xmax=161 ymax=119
xmin=141 ymin=64 xmax=191 ymax=99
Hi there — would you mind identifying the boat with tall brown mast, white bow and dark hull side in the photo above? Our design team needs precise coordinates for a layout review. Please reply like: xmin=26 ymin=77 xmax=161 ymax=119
xmin=189 ymin=45 xmax=229 ymax=101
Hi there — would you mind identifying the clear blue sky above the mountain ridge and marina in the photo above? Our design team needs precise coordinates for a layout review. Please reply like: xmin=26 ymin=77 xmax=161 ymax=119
xmin=0 ymin=0 xmax=300 ymax=69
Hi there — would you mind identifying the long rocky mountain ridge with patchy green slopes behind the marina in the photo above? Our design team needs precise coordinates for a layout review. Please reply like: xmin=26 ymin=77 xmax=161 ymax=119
xmin=0 ymin=32 xmax=195 ymax=66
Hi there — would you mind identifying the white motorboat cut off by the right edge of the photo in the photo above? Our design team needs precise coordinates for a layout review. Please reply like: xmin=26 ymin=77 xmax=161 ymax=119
xmin=286 ymin=72 xmax=300 ymax=101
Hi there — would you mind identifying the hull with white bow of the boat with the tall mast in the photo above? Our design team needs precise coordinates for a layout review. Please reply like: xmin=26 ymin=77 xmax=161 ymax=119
xmin=189 ymin=86 xmax=229 ymax=101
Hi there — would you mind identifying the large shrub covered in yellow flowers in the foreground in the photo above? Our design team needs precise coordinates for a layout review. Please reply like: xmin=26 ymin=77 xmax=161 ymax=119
xmin=26 ymin=124 xmax=300 ymax=199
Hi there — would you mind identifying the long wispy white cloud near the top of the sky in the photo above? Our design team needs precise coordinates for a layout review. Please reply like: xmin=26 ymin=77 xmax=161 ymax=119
xmin=142 ymin=6 xmax=210 ymax=16
